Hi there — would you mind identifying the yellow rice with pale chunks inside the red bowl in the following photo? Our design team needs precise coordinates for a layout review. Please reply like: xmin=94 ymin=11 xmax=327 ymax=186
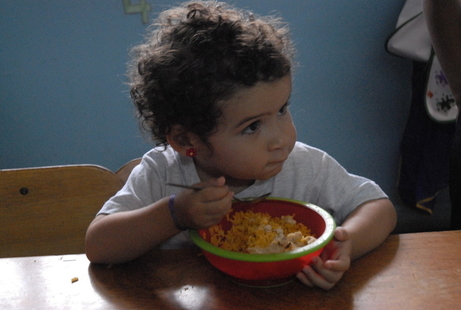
xmin=209 ymin=211 xmax=315 ymax=254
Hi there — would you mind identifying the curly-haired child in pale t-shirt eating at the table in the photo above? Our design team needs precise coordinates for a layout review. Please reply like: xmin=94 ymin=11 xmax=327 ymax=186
xmin=86 ymin=1 xmax=396 ymax=289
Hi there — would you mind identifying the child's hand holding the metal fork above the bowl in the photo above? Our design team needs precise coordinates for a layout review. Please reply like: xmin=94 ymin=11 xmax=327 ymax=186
xmin=174 ymin=177 xmax=234 ymax=229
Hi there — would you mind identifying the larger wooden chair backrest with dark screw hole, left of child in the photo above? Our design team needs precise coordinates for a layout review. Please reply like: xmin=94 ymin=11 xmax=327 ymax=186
xmin=0 ymin=165 xmax=123 ymax=257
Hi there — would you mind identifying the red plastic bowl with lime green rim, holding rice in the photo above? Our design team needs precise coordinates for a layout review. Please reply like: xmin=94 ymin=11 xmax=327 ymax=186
xmin=189 ymin=197 xmax=336 ymax=287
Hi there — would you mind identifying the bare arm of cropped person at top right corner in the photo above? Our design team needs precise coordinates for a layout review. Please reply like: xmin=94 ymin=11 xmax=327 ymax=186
xmin=424 ymin=0 xmax=461 ymax=108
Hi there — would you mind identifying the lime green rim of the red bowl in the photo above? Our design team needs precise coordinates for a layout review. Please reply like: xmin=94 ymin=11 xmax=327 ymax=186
xmin=189 ymin=197 xmax=336 ymax=262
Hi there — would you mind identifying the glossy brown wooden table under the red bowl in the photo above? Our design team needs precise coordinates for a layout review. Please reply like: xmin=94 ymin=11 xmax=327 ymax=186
xmin=0 ymin=231 xmax=461 ymax=310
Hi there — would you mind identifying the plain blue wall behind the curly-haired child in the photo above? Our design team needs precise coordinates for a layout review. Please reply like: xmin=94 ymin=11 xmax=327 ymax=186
xmin=0 ymin=0 xmax=411 ymax=201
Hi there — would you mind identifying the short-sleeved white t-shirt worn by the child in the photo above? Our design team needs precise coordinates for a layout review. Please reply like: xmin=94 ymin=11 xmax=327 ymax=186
xmin=98 ymin=142 xmax=387 ymax=248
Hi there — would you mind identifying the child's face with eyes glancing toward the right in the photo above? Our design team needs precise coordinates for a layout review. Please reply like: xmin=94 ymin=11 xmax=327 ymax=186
xmin=195 ymin=75 xmax=296 ymax=185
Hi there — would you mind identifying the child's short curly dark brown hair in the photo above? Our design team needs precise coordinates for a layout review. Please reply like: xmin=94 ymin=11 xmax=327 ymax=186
xmin=128 ymin=1 xmax=294 ymax=146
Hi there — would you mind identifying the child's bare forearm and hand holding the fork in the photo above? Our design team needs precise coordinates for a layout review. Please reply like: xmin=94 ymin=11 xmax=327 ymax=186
xmin=86 ymin=178 xmax=233 ymax=264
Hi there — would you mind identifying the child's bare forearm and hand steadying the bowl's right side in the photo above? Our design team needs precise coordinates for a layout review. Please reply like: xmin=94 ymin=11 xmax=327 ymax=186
xmin=298 ymin=199 xmax=397 ymax=290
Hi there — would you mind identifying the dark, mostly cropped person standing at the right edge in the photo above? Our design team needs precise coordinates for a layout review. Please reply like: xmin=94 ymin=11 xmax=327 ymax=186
xmin=424 ymin=0 xmax=461 ymax=229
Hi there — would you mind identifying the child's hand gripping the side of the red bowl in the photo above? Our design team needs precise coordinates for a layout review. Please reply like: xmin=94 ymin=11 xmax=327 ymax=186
xmin=297 ymin=227 xmax=351 ymax=290
